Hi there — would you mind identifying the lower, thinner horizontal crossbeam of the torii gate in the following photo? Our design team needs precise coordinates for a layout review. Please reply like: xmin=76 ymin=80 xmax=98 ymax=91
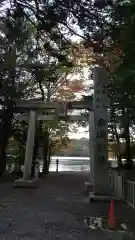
xmin=15 ymin=114 xmax=88 ymax=121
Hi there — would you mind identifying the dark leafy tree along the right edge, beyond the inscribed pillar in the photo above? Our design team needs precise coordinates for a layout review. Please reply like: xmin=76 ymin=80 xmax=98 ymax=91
xmin=104 ymin=1 xmax=135 ymax=168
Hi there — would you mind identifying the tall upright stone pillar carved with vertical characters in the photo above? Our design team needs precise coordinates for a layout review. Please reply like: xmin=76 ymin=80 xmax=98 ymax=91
xmin=91 ymin=67 xmax=110 ymax=198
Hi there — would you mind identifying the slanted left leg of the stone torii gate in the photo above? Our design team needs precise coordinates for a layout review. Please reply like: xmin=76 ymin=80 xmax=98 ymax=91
xmin=23 ymin=110 xmax=36 ymax=180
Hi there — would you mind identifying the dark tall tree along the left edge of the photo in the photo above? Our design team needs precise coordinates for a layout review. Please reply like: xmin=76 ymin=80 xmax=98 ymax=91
xmin=0 ymin=9 xmax=33 ymax=176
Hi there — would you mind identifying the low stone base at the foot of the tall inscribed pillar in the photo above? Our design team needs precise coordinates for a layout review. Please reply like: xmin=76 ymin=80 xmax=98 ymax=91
xmin=89 ymin=192 xmax=123 ymax=202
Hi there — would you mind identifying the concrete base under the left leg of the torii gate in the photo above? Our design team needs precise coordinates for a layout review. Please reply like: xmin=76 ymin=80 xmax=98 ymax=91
xmin=14 ymin=179 xmax=39 ymax=188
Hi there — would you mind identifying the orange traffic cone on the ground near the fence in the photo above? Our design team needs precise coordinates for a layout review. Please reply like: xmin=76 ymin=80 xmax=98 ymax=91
xmin=108 ymin=200 xmax=116 ymax=229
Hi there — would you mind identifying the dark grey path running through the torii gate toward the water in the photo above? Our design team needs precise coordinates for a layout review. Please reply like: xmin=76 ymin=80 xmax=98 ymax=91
xmin=0 ymin=173 xmax=134 ymax=240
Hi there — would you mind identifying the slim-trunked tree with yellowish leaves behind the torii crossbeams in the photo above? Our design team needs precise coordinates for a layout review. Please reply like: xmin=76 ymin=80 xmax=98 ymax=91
xmin=31 ymin=58 xmax=85 ymax=174
